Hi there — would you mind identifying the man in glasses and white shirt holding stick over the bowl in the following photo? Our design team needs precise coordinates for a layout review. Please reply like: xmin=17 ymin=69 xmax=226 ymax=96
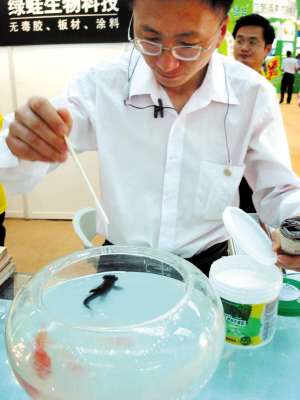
xmin=0 ymin=0 xmax=300 ymax=274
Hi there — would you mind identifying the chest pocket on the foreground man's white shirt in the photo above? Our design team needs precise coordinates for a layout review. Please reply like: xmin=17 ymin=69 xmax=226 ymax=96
xmin=195 ymin=161 xmax=245 ymax=221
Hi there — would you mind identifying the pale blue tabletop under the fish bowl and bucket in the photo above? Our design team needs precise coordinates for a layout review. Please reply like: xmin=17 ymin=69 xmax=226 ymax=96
xmin=0 ymin=274 xmax=300 ymax=400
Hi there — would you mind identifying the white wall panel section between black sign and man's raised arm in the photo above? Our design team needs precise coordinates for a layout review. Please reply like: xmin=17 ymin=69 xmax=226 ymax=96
xmin=13 ymin=43 xmax=123 ymax=107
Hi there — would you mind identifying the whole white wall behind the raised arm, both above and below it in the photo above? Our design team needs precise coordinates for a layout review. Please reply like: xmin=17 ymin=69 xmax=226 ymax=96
xmin=0 ymin=43 xmax=130 ymax=219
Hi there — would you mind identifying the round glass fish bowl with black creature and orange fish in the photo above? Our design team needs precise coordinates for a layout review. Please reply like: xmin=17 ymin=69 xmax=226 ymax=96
xmin=6 ymin=246 xmax=225 ymax=400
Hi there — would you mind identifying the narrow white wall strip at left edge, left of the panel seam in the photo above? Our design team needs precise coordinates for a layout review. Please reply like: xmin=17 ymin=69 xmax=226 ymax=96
xmin=0 ymin=47 xmax=14 ymax=115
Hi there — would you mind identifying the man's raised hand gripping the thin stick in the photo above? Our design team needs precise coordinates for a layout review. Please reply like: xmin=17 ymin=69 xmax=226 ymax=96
xmin=6 ymin=97 xmax=72 ymax=162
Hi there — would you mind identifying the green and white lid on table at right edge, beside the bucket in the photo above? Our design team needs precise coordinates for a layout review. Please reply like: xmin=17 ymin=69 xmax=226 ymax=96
xmin=278 ymin=278 xmax=300 ymax=317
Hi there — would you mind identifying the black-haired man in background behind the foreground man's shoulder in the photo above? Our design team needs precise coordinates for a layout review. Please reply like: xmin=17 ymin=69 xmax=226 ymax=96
xmin=232 ymin=14 xmax=275 ymax=213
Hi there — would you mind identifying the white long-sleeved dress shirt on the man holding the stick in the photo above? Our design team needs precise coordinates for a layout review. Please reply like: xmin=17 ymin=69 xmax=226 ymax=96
xmin=0 ymin=52 xmax=300 ymax=258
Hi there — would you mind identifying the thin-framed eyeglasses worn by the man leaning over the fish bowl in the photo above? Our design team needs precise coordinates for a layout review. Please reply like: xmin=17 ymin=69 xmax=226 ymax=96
xmin=128 ymin=15 xmax=224 ymax=61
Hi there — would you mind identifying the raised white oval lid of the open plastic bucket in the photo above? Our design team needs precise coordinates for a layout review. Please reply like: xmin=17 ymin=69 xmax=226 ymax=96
xmin=223 ymin=207 xmax=277 ymax=265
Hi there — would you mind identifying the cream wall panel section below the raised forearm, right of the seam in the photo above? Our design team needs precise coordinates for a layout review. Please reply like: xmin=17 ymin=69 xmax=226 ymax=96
xmin=27 ymin=152 xmax=99 ymax=219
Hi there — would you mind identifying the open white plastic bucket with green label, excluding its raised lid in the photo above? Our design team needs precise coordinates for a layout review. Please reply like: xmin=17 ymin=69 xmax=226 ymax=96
xmin=209 ymin=256 xmax=282 ymax=348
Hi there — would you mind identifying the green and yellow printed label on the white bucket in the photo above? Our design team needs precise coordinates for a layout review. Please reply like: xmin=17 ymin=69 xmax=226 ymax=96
xmin=221 ymin=298 xmax=278 ymax=346
